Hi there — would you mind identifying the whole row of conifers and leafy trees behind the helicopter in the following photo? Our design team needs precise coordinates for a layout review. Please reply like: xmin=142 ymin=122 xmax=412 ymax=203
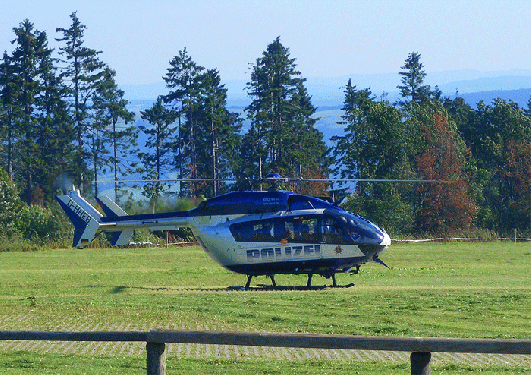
xmin=0 ymin=13 xmax=531 ymax=250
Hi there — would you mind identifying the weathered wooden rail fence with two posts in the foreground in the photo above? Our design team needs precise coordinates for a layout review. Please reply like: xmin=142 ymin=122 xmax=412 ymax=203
xmin=0 ymin=330 xmax=531 ymax=375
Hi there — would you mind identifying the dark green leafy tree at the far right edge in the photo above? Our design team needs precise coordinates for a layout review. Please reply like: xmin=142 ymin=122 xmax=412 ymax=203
xmin=465 ymin=98 xmax=531 ymax=234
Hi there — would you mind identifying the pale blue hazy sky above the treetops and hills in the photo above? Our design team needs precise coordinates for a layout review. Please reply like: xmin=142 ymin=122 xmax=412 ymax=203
xmin=0 ymin=0 xmax=531 ymax=84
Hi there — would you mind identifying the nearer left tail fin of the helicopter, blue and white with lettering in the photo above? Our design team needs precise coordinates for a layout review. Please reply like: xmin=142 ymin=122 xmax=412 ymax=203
xmin=57 ymin=189 xmax=102 ymax=247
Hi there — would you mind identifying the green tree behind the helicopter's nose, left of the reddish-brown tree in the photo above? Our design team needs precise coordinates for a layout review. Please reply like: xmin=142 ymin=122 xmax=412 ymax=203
xmin=332 ymin=80 xmax=414 ymax=233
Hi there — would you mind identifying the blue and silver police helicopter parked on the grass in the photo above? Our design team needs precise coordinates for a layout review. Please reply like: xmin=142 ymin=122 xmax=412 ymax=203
xmin=57 ymin=174 xmax=391 ymax=289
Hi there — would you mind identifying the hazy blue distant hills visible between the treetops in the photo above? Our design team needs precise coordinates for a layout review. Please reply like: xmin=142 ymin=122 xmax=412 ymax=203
xmin=121 ymin=69 xmax=531 ymax=110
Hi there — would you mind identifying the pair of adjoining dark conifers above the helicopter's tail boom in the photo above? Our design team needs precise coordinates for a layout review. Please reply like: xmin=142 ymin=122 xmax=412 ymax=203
xmin=164 ymin=49 xmax=241 ymax=196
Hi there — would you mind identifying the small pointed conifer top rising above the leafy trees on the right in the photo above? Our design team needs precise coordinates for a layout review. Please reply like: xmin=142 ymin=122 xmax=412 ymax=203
xmin=397 ymin=52 xmax=434 ymax=104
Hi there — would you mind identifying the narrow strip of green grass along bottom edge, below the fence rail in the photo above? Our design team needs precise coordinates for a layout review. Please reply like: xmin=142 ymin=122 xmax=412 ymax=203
xmin=0 ymin=352 xmax=529 ymax=375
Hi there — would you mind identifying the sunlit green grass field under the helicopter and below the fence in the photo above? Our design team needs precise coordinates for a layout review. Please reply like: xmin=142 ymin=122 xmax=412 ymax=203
xmin=0 ymin=242 xmax=531 ymax=374
